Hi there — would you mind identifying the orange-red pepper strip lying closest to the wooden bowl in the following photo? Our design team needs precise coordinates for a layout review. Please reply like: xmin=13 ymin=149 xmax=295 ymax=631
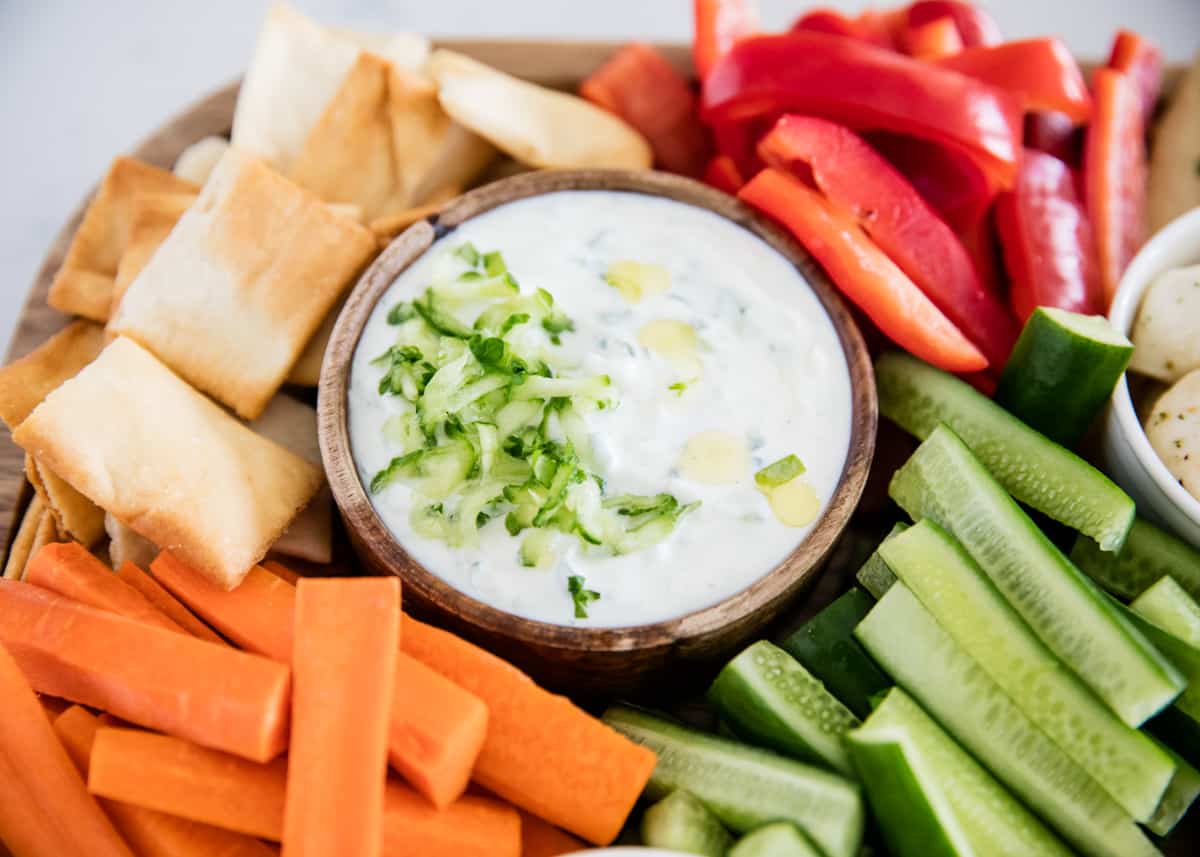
xmin=738 ymin=168 xmax=988 ymax=372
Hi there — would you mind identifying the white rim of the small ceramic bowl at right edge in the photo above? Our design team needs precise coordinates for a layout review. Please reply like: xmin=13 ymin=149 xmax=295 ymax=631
xmin=1109 ymin=206 xmax=1200 ymax=526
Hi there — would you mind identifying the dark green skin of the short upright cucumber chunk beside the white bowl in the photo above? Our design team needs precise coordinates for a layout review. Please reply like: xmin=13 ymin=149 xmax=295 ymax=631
xmin=996 ymin=307 xmax=1133 ymax=447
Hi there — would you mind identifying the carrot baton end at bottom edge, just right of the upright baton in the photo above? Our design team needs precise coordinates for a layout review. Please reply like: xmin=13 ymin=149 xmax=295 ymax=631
xmin=383 ymin=783 xmax=522 ymax=857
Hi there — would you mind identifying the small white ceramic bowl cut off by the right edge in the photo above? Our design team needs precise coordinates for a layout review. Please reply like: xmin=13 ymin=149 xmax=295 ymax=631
xmin=1104 ymin=208 xmax=1200 ymax=547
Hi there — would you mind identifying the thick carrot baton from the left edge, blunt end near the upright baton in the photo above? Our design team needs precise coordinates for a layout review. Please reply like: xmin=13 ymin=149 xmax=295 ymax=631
xmin=0 ymin=581 xmax=290 ymax=761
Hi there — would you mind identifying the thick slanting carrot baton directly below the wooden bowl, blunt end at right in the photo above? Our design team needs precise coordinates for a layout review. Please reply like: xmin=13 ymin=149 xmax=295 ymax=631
xmin=402 ymin=616 xmax=656 ymax=845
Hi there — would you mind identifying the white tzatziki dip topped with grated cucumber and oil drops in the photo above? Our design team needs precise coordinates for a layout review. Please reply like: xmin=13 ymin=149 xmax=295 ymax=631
xmin=348 ymin=191 xmax=851 ymax=627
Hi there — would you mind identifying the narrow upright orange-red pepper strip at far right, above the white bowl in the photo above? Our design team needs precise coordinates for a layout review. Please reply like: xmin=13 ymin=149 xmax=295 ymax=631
xmin=1084 ymin=68 xmax=1146 ymax=303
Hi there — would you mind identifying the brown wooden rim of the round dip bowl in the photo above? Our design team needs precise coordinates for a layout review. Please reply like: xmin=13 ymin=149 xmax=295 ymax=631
xmin=317 ymin=169 xmax=878 ymax=652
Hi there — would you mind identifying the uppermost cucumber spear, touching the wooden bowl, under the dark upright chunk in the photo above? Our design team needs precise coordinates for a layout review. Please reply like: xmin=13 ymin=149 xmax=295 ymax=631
xmin=875 ymin=352 xmax=1134 ymax=551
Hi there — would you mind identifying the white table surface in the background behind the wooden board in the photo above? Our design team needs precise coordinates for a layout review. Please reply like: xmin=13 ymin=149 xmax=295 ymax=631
xmin=0 ymin=0 xmax=1200 ymax=352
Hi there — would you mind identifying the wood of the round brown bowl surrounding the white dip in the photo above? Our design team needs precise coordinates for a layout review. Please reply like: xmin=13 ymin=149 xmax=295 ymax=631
xmin=317 ymin=170 xmax=877 ymax=695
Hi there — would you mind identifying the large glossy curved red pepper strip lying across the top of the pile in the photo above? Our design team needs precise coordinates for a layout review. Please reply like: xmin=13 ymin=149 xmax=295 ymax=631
xmin=702 ymin=32 xmax=1022 ymax=187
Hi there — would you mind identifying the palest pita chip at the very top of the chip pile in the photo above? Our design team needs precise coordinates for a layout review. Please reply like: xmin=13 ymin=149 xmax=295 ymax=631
xmin=232 ymin=4 xmax=428 ymax=174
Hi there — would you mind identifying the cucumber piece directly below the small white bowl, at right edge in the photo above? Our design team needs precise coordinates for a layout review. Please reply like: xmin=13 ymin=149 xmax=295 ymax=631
xmin=1070 ymin=517 xmax=1200 ymax=601
